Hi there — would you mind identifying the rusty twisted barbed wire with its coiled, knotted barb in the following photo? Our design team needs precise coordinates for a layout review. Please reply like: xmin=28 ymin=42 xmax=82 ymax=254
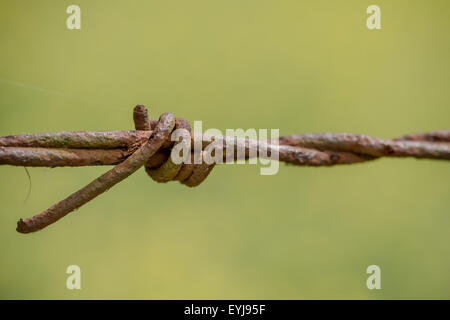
xmin=0 ymin=105 xmax=450 ymax=233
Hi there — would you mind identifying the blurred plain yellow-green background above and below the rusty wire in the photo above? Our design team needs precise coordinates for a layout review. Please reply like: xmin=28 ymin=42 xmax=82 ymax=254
xmin=0 ymin=0 xmax=450 ymax=299
